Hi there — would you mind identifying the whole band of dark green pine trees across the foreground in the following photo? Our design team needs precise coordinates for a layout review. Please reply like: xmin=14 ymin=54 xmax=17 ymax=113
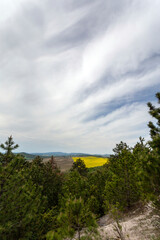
xmin=0 ymin=93 xmax=160 ymax=240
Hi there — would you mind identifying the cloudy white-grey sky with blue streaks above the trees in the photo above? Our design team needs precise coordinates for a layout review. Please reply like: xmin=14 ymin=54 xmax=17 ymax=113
xmin=0 ymin=0 xmax=160 ymax=154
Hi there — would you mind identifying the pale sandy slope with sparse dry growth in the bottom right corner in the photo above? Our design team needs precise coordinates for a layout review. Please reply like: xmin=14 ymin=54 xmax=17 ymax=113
xmin=99 ymin=204 xmax=160 ymax=240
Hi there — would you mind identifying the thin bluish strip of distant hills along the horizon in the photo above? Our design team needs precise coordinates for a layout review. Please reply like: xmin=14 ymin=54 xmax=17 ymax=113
xmin=19 ymin=152 xmax=110 ymax=160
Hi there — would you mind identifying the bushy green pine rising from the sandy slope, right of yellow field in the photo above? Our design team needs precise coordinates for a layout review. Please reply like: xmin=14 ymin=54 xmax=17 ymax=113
xmin=105 ymin=142 xmax=139 ymax=208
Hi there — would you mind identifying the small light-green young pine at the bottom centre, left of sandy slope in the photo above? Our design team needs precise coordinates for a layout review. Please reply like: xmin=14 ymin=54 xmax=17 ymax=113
xmin=47 ymin=198 xmax=98 ymax=240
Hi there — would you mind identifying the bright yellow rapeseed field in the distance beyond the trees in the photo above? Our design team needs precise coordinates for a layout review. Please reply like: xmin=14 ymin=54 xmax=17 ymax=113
xmin=72 ymin=156 xmax=108 ymax=168
